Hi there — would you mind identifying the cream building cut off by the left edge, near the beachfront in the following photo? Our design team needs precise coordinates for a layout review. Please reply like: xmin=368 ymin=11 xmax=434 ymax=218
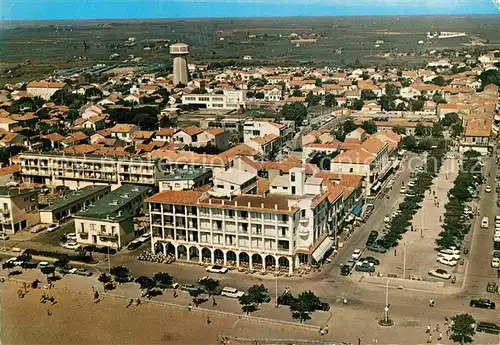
xmin=0 ymin=187 xmax=40 ymax=234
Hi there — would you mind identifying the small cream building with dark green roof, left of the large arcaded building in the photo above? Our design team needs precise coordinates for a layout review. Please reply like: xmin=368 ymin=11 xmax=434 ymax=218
xmin=73 ymin=184 xmax=150 ymax=249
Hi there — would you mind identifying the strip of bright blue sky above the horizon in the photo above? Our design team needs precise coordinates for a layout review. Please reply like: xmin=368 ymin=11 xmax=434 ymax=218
xmin=0 ymin=0 xmax=500 ymax=20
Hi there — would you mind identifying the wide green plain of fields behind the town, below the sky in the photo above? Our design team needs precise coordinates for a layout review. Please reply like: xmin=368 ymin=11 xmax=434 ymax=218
xmin=0 ymin=16 xmax=500 ymax=83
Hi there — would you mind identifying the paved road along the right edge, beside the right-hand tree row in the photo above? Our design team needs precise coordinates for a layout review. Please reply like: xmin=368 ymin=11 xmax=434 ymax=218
xmin=462 ymin=157 xmax=500 ymax=296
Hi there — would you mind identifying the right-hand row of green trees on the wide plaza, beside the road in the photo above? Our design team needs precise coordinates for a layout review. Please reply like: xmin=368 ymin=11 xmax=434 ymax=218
xmin=436 ymin=151 xmax=483 ymax=248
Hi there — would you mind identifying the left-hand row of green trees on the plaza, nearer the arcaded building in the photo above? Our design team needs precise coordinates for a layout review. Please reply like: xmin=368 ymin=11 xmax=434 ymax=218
xmin=377 ymin=141 xmax=445 ymax=249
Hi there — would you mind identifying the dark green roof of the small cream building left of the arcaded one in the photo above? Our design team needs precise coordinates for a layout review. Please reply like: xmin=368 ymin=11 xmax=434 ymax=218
xmin=75 ymin=184 xmax=150 ymax=219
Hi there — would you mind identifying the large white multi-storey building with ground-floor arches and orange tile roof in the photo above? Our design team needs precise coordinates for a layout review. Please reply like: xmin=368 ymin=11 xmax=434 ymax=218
xmin=146 ymin=169 xmax=342 ymax=273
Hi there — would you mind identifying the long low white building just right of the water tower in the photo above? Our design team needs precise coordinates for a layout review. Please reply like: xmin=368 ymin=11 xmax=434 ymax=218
xmin=182 ymin=90 xmax=246 ymax=110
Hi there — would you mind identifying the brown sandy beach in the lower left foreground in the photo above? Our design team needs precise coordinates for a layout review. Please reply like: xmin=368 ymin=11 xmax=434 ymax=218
xmin=2 ymin=281 xmax=325 ymax=345
